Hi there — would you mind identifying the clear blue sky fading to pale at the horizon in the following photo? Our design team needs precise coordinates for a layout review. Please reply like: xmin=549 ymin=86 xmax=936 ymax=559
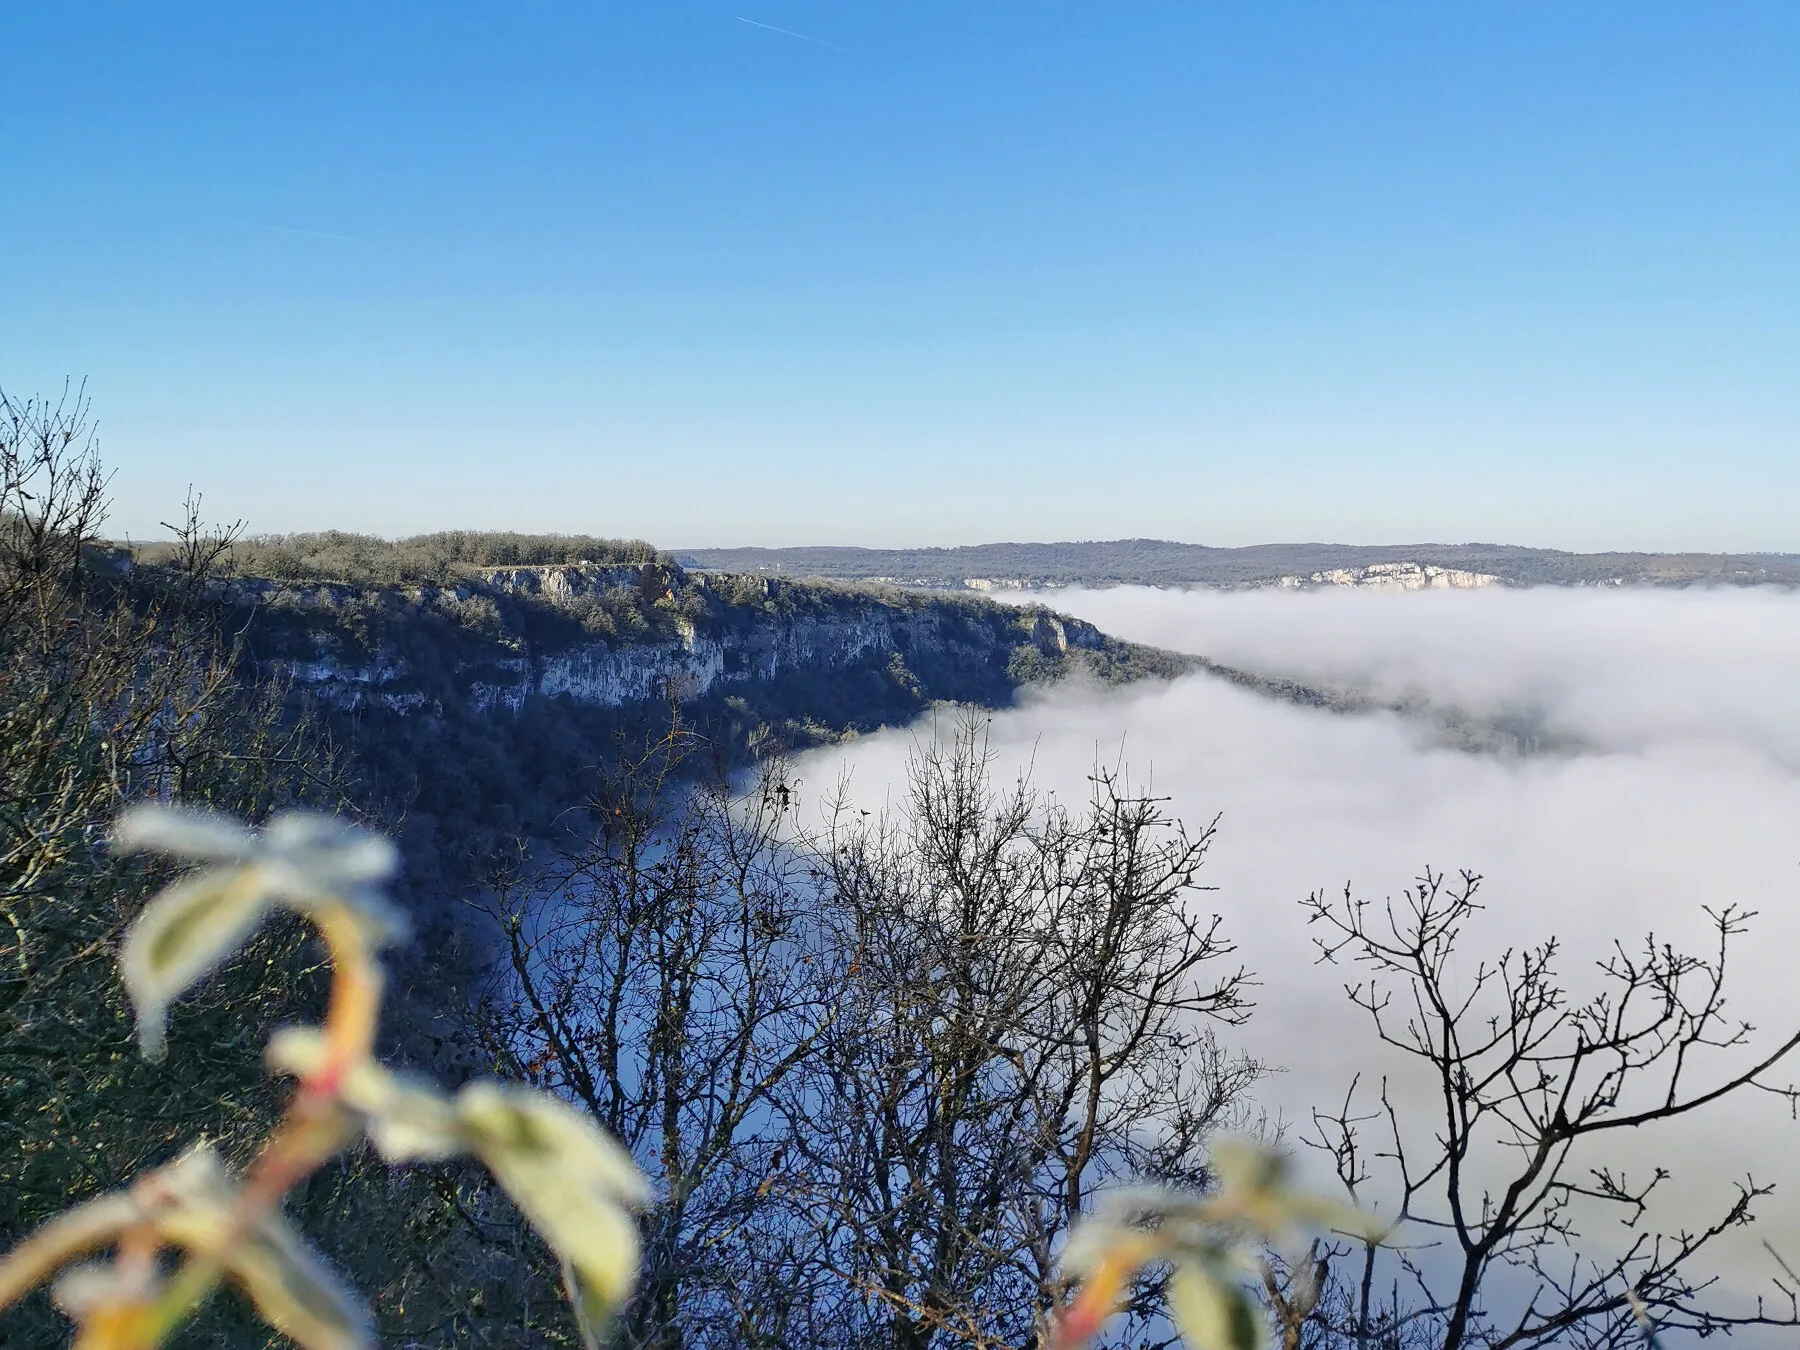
xmin=0 ymin=0 xmax=1800 ymax=551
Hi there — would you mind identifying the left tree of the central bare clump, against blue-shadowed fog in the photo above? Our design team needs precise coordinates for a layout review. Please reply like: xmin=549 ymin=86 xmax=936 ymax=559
xmin=486 ymin=725 xmax=833 ymax=1346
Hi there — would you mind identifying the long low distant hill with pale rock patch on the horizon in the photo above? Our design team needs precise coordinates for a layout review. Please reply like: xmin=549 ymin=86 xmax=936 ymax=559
xmin=677 ymin=538 xmax=1800 ymax=590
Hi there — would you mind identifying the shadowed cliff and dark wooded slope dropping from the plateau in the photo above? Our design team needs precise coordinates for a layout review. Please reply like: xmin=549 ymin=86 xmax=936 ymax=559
xmin=193 ymin=560 xmax=1188 ymax=911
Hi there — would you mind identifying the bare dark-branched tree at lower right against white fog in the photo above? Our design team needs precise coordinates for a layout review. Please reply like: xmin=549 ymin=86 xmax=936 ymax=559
xmin=1274 ymin=873 xmax=1800 ymax=1350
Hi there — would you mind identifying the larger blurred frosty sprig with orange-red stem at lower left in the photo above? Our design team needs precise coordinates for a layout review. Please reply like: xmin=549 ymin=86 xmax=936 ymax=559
xmin=0 ymin=806 xmax=650 ymax=1350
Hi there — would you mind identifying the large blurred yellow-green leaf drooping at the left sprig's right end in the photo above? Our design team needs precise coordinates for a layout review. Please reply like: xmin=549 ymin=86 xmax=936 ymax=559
xmin=457 ymin=1084 xmax=650 ymax=1323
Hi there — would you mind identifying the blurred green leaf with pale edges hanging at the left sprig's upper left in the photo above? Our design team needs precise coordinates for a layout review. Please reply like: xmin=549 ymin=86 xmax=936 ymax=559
xmin=119 ymin=866 xmax=270 ymax=1060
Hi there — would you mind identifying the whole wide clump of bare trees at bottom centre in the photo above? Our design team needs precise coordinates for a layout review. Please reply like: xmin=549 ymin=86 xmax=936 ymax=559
xmin=464 ymin=722 xmax=1258 ymax=1346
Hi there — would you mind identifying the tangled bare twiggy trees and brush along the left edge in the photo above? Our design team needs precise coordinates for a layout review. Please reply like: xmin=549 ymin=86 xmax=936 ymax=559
xmin=0 ymin=389 xmax=349 ymax=1336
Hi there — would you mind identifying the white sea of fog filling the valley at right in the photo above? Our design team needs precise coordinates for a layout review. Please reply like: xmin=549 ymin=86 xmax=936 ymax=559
xmin=801 ymin=587 xmax=1800 ymax=1310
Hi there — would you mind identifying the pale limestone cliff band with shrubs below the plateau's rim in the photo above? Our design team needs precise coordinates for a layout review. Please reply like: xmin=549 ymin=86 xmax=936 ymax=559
xmin=229 ymin=563 xmax=1125 ymax=713
